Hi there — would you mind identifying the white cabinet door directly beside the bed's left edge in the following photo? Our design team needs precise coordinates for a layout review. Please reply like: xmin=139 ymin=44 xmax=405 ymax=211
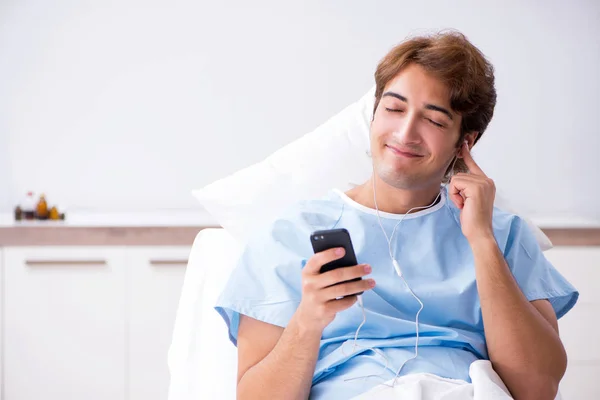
xmin=127 ymin=247 xmax=191 ymax=400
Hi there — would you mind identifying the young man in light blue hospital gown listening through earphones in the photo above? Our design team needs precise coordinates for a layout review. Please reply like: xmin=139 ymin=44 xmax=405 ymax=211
xmin=216 ymin=33 xmax=578 ymax=400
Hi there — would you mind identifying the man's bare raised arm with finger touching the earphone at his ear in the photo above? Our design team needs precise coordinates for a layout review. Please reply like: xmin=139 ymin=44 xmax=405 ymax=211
xmin=449 ymin=139 xmax=567 ymax=400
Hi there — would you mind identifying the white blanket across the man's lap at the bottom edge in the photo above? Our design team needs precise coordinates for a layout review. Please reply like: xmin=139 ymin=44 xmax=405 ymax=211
xmin=354 ymin=360 xmax=512 ymax=400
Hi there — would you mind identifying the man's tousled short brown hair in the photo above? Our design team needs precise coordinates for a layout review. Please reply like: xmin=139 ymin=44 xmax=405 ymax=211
xmin=373 ymin=31 xmax=496 ymax=182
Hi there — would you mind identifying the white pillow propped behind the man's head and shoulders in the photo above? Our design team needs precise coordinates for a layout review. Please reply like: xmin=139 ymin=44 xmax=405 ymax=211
xmin=192 ymin=87 xmax=552 ymax=250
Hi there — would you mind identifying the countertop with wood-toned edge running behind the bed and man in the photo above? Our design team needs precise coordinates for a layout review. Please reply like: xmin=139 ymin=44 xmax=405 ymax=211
xmin=0 ymin=210 xmax=600 ymax=247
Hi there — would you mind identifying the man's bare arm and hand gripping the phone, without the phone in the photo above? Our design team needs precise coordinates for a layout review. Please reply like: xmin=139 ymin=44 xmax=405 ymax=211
xmin=237 ymin=249 xmax=374 ymax=400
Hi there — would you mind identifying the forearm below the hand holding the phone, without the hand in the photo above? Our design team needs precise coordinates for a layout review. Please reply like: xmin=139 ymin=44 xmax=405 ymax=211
xmin=237 ymin=316 xmax=321 ymax=400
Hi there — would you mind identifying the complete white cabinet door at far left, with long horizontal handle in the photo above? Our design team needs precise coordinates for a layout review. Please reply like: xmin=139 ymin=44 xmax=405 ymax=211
xmin=4 ymin=247 xmax=127 ymax=400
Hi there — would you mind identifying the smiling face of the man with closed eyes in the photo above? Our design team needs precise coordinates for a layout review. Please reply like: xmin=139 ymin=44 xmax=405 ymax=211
xmin=371 ymin=64 xmax=461 ymax=189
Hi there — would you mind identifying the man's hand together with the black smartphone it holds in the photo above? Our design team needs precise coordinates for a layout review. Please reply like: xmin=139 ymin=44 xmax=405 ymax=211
xmin=297 ymin=229 xmax=375 ymax=330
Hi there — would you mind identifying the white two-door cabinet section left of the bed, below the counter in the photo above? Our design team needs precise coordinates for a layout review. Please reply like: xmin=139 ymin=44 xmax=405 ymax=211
xmin=0 ymin=246 xmax=191 ymax=400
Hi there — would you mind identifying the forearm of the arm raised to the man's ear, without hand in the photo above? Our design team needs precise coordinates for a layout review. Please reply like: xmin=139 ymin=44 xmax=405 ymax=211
xmin=471 ymin=236 xmax=566 ymax=400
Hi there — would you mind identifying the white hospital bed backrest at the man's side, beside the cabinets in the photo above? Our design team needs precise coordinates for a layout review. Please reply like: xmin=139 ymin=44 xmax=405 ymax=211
xmin=168 ymin=229 xmax=570 ymax=400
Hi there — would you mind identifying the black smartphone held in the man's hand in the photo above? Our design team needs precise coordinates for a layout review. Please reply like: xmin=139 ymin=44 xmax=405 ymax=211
xmin=310 ymin=228 xmax=363 ymax=295
